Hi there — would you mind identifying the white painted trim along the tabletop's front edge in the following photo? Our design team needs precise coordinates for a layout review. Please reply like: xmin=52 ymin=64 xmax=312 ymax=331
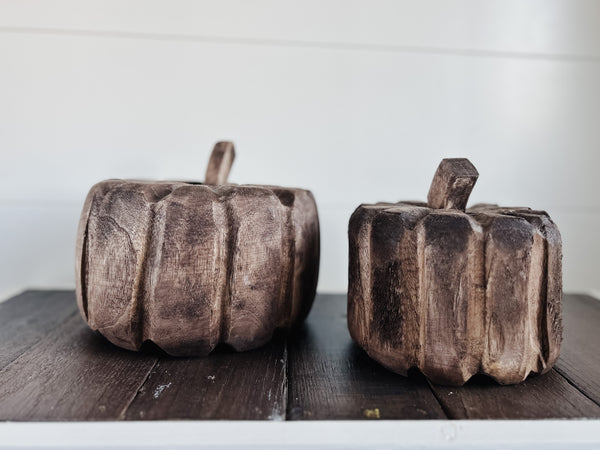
xmin=0 ymin=420 xmax=600 ymax=450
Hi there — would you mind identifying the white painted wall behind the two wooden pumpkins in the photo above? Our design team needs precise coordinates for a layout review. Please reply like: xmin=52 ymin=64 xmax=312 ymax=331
xmin=0 ymin=0 xmax=600 ymax=297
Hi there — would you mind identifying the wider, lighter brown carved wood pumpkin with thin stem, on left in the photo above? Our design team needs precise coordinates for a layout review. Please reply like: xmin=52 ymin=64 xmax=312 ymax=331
xmin=76 ymin=142 xmax=319 ymax=356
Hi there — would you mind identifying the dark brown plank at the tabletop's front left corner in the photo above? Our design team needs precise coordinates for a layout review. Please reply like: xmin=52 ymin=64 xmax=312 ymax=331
xmin=0 ymin=310 xmax=156 ymax=421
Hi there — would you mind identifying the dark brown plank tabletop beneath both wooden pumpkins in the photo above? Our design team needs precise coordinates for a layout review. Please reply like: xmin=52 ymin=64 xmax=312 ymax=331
xmin=0 ymin=291 xmax=600 ymax=421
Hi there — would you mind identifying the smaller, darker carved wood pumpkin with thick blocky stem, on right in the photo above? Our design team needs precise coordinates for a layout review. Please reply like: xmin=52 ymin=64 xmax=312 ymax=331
xmin=348 ymin=159 xmax=562 ymax=385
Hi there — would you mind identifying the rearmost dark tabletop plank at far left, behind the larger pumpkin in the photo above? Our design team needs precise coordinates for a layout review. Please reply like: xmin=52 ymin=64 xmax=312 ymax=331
xmin=0 ymin=291 xmax=77 ymax=369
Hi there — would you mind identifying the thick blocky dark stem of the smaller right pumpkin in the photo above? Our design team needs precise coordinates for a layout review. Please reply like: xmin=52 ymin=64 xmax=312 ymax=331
xmin=427 ymin=158 xmax=479 ymax=211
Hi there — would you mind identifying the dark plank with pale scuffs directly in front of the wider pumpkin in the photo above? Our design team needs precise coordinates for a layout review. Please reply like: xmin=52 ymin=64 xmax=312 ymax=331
xmin=125 ymin=334 xmax=287 ymax=420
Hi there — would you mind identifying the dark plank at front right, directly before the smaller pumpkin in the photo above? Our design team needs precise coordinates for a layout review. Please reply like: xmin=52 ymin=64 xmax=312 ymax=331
xmin=431 ymin=370 xmax=600 ymax=419
